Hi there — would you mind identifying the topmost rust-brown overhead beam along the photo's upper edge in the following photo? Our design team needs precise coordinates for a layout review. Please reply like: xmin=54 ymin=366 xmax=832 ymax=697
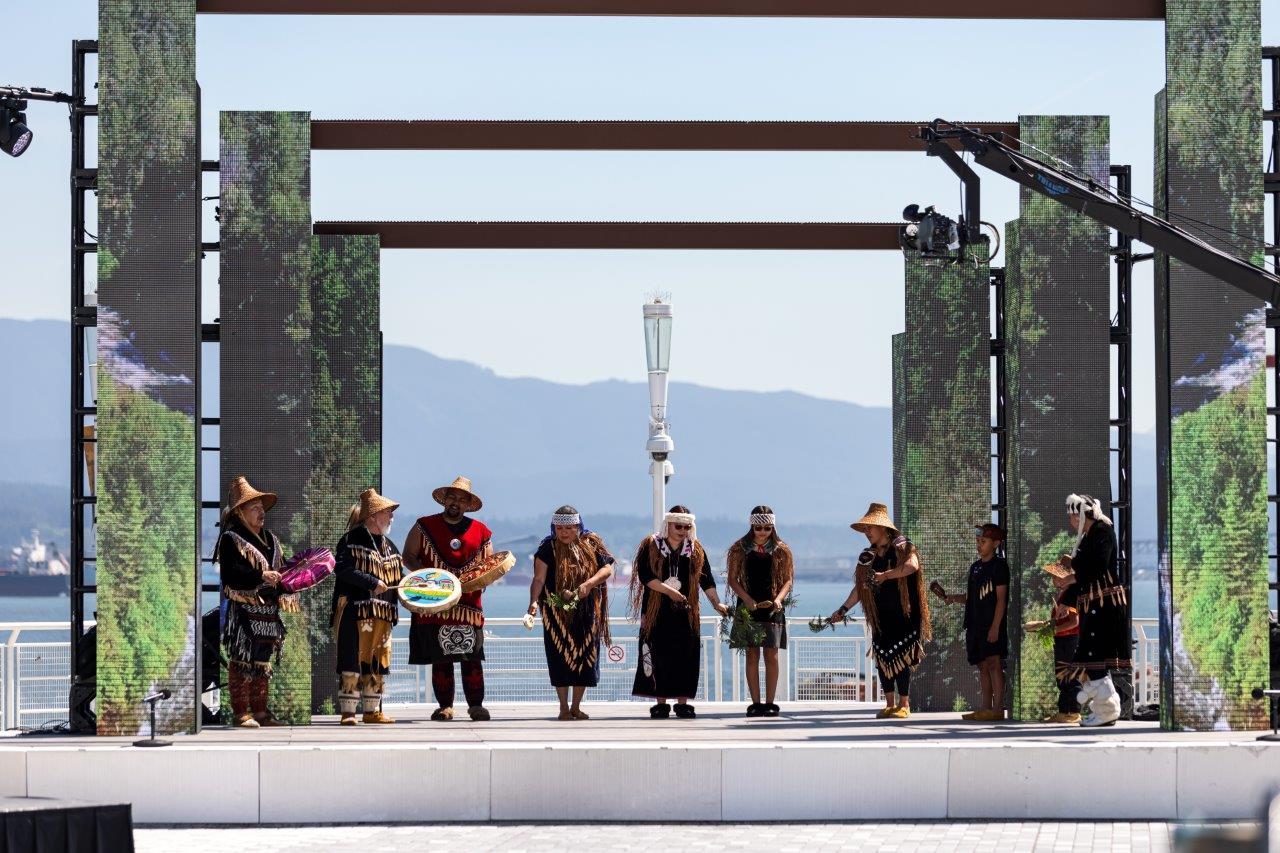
xmin=196 ymin=0 xmax=1165 ymax=20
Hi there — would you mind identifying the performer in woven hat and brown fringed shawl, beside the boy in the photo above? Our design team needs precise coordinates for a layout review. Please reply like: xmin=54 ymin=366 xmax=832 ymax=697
xmin=829 ymin=503 xmax=933 ymax=720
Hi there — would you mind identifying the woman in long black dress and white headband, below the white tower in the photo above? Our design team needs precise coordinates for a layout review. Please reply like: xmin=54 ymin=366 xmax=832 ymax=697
xmin=631 ymin=505 xmax=728 ymax=720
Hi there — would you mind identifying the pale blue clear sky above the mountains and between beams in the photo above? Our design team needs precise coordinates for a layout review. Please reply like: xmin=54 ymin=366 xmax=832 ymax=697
xmin=0 ymin=0 xmax=1280 ymax=430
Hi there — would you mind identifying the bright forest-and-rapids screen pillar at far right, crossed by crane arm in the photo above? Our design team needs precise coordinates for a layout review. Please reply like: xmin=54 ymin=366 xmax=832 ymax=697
xmin=1156 ymin=0 xmax=1268 ymax=730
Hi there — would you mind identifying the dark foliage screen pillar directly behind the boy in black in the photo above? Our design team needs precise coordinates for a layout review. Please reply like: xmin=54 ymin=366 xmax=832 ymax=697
xmin=1005 ymin=115 xmax=1111 ymax=720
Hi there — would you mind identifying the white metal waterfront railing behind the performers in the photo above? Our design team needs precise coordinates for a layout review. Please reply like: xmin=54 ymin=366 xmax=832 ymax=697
xmin=0 ymin=619 xmax=1160 ymax=730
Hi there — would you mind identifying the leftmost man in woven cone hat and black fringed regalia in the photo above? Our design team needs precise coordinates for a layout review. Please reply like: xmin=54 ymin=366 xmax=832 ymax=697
xmin=214 ymin=476 xmax=291 ymax=729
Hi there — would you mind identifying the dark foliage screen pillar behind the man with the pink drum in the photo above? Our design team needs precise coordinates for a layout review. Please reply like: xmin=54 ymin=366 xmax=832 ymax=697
xmin=219 ymin=111 xmax=317 ymax=725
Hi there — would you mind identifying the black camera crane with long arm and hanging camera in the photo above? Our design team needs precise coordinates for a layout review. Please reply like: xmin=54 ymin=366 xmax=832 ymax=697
xmin=899 ymin=119 xmax=1280 ymax=307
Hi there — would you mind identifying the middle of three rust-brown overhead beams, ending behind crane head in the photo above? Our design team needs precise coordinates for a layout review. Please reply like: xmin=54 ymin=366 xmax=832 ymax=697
xmin=311 ymin=119 xmax=1018 ymax=151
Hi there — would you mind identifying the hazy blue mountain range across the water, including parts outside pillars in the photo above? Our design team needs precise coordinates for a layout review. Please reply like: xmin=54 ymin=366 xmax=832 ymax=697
xmin=0 ymin=319 xmax=1155 ymax=555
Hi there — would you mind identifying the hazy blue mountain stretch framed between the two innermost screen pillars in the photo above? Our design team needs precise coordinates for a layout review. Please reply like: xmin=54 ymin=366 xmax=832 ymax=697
xmin=383 ymin=346 xmax=892 ymax=524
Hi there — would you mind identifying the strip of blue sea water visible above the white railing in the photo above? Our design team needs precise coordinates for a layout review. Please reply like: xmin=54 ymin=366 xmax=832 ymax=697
xmin=0 ymin=578 xmax=1157 ymax=622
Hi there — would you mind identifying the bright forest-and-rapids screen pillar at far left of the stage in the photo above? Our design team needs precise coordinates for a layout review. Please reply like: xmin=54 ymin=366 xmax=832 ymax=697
xmin=96 ymin=0 xmax=200 ymax=735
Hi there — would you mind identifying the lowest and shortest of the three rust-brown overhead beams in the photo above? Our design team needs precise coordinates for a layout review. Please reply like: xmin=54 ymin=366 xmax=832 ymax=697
xmin=315 ymin=222 xmax=899 ymax=250
